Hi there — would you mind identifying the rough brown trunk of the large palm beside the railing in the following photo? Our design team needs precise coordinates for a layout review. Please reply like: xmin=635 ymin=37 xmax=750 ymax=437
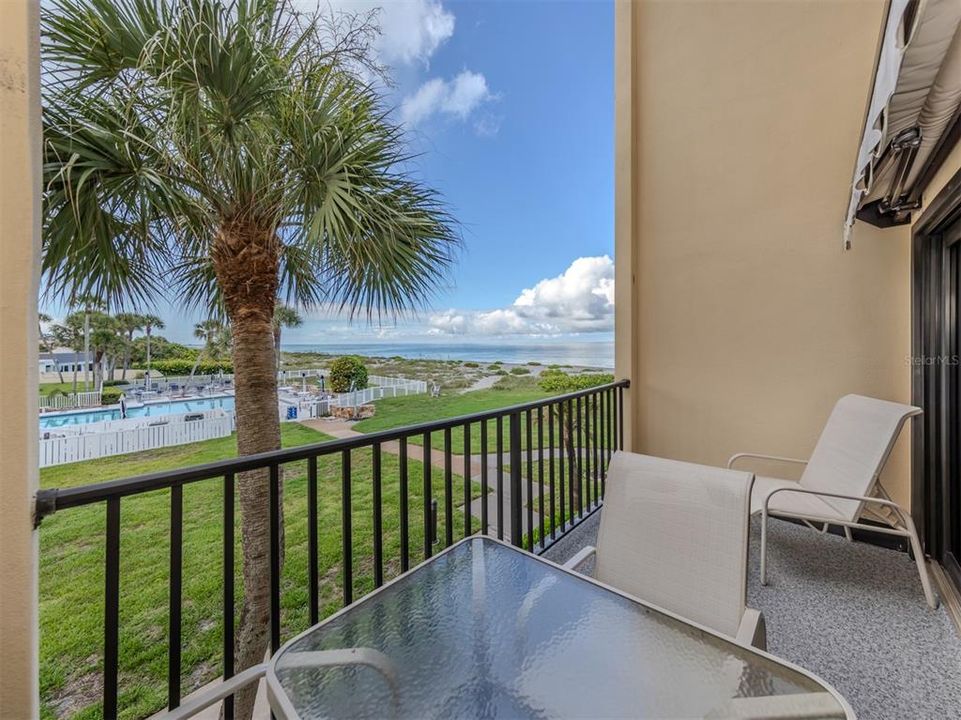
xmin=211 ymin=221 xmax=283 ymax=720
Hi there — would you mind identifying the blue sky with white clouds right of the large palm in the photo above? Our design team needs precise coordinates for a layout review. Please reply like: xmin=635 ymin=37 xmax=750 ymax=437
xmin=41 ymin=0 xmax=614 ymax=343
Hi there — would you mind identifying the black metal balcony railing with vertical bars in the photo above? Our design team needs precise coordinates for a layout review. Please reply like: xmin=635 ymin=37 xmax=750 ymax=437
xmin=36 ymin=380 xmax=629 ymax=719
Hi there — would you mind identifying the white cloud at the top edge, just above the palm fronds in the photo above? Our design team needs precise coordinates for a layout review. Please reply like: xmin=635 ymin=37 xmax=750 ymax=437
xmin=318 ymin=0 xmax=454 ymax=65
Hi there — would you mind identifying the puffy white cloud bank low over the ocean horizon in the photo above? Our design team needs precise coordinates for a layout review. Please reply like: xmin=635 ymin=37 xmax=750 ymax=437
xmin=428 ymin=255 xmax=614 ymax=335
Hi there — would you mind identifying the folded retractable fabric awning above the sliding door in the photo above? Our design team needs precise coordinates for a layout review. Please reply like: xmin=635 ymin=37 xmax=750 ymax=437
xmin=844 ymin=0 xmax=961 ymax=246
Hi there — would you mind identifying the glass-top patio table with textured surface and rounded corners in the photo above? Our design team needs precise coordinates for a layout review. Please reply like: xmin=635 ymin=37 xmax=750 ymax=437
xmin=267 ymin=537 xmax=853 ymax=720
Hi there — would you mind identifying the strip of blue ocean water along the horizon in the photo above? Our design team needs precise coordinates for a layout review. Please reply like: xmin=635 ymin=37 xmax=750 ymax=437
xmin=283 ymin=341 xmax=614 ymax=369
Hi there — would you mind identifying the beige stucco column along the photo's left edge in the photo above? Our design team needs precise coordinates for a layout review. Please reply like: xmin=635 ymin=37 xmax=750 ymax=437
xmin=0 ymin=0 xmax=41 ymax=720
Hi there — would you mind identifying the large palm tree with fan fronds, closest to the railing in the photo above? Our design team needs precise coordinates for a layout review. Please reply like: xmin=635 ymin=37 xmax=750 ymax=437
xmin=41 ymin=0 xmax=457 ymax=718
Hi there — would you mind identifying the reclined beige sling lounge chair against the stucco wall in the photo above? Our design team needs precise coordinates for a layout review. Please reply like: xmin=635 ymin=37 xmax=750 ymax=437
xmin=727 ymin=395 xmax=938 ymax=608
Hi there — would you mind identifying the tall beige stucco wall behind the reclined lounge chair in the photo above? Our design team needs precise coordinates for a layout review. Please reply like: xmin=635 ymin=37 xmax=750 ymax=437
xmin=617 ymin=0 xmax=910 ymax=503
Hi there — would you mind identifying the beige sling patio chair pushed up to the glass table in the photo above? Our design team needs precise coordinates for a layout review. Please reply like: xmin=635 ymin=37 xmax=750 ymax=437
xmin=565 ymin=452 xmax=766 ymax=650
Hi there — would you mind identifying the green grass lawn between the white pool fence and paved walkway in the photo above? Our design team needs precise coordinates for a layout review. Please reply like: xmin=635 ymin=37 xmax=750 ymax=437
xmin=40 ymin=423 xmax=478 ymax=720
